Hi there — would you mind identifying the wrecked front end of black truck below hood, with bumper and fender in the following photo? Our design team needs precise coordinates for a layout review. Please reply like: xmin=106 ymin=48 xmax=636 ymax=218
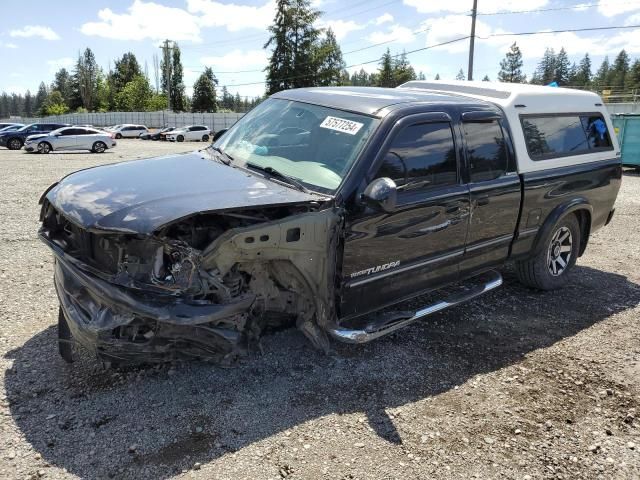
xmin=40 ymin=199 xmax=341 ymax=365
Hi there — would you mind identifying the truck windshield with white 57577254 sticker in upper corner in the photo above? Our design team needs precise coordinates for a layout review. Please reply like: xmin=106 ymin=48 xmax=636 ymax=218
xmin=214 ymin=99 xmax=379 ymax=192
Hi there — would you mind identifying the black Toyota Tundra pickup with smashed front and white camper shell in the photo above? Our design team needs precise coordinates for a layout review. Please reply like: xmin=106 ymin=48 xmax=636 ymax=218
xmin=40 ymin=82 xmax=622 ymax=365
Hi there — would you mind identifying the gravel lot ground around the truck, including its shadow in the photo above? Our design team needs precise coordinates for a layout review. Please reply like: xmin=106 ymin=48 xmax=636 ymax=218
xmin=0 ymin=140 xmax=640 ymax=479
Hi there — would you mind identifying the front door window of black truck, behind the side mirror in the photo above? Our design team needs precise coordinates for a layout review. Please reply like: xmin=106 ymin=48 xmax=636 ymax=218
xmin=376 ymin=122 xmax=458 ymax=190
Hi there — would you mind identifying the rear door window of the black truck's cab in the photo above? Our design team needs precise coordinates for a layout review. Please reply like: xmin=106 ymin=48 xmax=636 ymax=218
xmin=463 ymin=120 xmax=508 ymax=182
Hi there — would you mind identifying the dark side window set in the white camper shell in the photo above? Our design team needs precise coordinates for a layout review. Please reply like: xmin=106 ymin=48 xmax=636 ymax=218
xmin=521 ymin=113 xmax=613 ymax=160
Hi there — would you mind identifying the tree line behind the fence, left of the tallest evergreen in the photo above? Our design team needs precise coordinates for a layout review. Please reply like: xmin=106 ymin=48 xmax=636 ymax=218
xmin=0 ymin=45 xmax=261 ymax=118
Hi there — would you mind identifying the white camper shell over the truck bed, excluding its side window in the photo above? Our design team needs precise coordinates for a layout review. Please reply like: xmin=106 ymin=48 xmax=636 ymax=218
xmin=398 ymin=81 xmax=620 ymax=173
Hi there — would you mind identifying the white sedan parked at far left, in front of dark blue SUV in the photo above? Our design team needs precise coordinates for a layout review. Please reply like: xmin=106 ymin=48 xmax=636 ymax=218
xmin=24 ymin=127 xmax=116 ymax=153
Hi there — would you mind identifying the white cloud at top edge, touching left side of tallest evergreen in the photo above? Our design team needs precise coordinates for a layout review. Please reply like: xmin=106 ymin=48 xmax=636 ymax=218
xmin=187 ymin=0 xmax=276 ymax=32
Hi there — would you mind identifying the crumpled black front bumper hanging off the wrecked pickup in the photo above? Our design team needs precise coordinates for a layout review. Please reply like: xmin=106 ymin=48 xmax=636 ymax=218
xmin=54 ymin=254 xmax=253 ymax=364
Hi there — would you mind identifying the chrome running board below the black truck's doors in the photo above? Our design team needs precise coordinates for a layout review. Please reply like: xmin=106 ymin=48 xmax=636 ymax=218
xmin=329 ymin=271 xmax=502 ymax=343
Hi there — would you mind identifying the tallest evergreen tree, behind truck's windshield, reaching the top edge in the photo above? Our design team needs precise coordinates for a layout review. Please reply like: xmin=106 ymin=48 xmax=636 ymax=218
xmin=264 ymin=0 xmax=321 ymax=95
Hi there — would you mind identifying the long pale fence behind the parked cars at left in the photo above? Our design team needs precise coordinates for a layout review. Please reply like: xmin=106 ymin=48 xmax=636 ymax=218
xmin=0 ymin=112 xmax=244 ymax=132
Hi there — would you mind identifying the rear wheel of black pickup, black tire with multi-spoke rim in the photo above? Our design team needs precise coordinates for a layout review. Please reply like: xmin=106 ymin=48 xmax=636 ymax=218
xmin=515 ymin=214 xmax=582 ymax=290
